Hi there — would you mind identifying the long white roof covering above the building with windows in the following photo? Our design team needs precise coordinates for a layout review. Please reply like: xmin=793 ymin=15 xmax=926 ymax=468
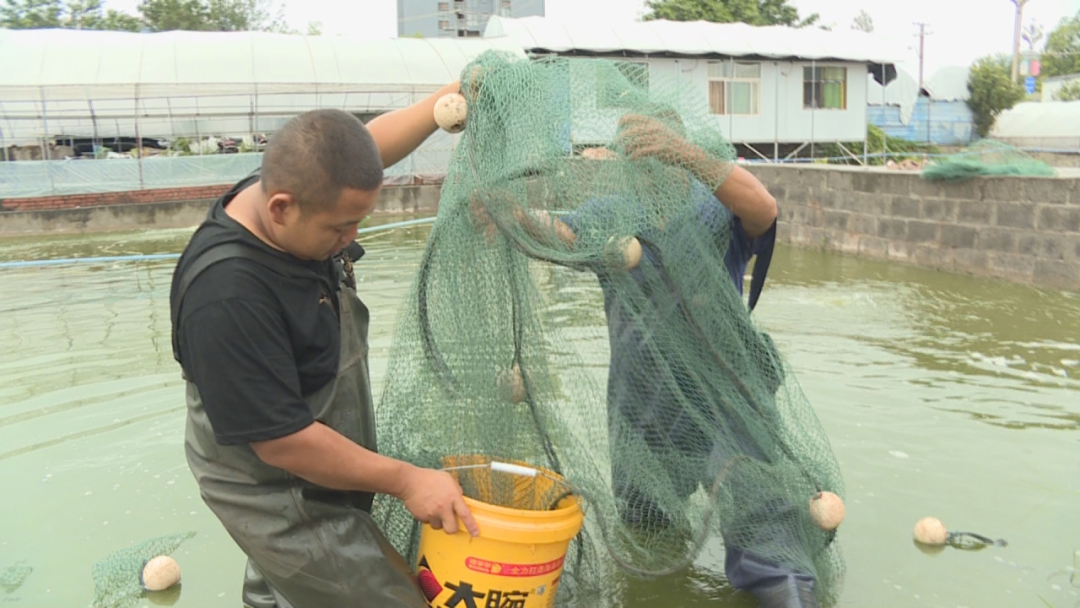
xmin=484 ymin=16 xmax=901 ymax=65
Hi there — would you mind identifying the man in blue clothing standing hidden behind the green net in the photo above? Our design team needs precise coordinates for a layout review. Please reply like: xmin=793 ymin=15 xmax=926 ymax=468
xmin=467 ymin=70 xmax=832 ymax=608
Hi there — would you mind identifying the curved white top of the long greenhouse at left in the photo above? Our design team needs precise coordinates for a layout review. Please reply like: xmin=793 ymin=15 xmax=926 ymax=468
xmin=0 ymin=29 xmax=524 ymax=102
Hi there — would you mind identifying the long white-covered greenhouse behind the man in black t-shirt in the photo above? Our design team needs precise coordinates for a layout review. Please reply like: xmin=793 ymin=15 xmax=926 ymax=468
xmin=0 ymin=29 xmax=524 ymax=198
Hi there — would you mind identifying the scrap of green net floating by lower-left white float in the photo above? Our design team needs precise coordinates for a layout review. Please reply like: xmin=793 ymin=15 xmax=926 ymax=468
xmin=91 ymin=532 xmax=195 ymax=608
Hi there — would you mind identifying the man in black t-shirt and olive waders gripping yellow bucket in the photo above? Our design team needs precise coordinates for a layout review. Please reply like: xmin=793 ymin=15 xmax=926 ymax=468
xmin=171 ymin=83 xmax=477 ymax=608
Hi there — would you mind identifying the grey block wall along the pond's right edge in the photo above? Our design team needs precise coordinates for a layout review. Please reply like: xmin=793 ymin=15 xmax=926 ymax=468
xmin=750 ymin=165 xmax=1080 ymax=291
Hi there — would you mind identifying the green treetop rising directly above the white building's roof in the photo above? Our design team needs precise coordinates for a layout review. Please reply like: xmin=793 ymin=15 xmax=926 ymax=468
xmin=644 ymin=0 xmax=819 ymax=27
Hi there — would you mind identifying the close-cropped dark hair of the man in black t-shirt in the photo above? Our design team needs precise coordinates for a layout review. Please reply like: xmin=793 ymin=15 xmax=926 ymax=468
xmin=261 ymin=109 xmax=382 ymax=212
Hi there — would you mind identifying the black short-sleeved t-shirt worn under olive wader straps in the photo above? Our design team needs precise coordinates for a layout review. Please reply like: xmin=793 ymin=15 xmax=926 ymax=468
xmin=171 ymin=175 xmax=363 ymax=445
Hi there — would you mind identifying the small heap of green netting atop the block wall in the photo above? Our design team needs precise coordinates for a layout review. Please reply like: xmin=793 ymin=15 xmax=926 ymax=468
xmin=922 ymin=139 xmax=1056 ymax=181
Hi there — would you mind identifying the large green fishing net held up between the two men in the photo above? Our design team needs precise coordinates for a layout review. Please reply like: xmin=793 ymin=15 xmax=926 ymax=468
xmin=375 ymin=52 xmax=843 ymax=606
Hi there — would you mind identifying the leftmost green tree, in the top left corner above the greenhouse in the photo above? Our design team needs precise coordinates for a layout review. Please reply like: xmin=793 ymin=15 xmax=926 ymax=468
xmin=0 ymin=0 xmax=141 ymax=31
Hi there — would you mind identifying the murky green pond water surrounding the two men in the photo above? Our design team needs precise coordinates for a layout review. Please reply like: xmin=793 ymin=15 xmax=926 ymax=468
xmin=0 ymin=219 xmax=1080 ymax=608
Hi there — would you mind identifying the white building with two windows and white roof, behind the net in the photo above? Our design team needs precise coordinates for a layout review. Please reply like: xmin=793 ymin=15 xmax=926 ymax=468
xmin=484 ymin=16 xmax=900 ymax=158
